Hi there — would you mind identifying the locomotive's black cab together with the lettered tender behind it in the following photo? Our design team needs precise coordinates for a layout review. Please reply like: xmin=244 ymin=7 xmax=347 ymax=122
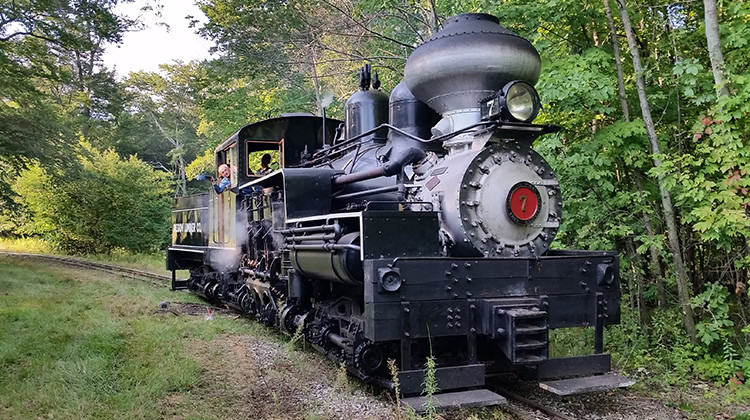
xmin=167 ymin=114 xmax=342 ymax=286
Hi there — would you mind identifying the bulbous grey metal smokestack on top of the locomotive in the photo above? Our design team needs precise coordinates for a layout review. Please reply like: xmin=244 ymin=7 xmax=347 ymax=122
xmin=404 ymin=13 xmax=541 ymax=141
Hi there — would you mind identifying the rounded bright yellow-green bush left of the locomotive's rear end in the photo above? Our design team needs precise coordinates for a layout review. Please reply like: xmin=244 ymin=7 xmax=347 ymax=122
xmin=14 ymin=143 xmax=170 ymax=253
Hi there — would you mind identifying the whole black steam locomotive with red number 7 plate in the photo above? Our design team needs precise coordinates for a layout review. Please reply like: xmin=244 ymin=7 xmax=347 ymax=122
xmin=167 ymin=14 xmax=624 ymax=404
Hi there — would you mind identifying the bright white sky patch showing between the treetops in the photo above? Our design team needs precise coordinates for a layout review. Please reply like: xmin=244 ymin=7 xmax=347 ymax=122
xmin=103 ymin=0 xmax=212 ymax=78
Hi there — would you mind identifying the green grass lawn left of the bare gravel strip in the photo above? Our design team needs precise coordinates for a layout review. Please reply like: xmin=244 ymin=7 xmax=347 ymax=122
xmin=0 ymin=257 xmax=253 ymax=419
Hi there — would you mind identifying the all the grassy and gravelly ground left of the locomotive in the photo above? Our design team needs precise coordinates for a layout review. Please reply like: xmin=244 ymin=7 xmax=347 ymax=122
xmin=0 ymin=256 xmax=402 ymax=420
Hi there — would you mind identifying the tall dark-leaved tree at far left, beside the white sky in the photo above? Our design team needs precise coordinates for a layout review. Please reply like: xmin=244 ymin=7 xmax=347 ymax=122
xmin=0 ymin=0 xmax=133 ymax=205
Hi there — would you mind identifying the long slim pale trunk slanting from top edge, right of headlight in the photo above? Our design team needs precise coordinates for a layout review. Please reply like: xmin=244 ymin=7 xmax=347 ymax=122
xmin=617 ymin=0 xmax=698 ymax=344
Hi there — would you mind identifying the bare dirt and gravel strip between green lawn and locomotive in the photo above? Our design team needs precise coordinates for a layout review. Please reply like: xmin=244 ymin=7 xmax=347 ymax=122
xmin=154 ymin=304 xmax=396 ymax=420
